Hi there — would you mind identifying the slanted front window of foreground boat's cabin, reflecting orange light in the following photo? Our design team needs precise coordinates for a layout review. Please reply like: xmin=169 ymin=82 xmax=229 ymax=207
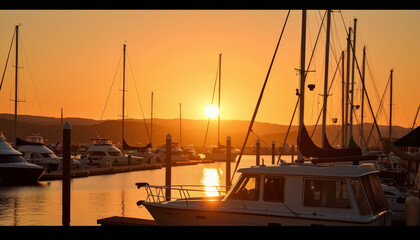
xmin=230 ymin=176 xmax=259 ymax=201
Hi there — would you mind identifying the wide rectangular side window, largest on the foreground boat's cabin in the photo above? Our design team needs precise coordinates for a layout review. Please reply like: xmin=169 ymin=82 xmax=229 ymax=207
xmin=304 ymin=179 xmax=351 ymax=208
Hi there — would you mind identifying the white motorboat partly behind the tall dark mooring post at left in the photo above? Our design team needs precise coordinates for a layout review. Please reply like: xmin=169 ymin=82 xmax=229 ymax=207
xmin=16 ymin=134 xmax=84 ymax=172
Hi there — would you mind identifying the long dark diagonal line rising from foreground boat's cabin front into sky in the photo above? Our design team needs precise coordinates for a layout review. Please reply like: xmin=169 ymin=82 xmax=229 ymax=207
xmin=231 ymin=10 xmax=290 ymax=180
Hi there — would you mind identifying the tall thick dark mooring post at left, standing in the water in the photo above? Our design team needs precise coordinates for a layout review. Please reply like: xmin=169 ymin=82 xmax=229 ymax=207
xmin=62 ymin=122 xmax=72 ymax=226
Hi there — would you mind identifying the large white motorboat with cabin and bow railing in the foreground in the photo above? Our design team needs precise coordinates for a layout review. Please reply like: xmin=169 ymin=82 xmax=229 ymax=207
xmin=136 ymin=163 xmax=391 ymax=226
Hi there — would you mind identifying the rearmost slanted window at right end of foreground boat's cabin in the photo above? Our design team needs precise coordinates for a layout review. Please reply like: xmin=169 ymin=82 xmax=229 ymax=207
xmin=361 ymin=174 xmax=388 ymax=214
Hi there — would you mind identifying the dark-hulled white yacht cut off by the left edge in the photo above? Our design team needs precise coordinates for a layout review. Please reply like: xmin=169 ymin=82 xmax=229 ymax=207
xmin=0 ymin=133 xmax=45 ymax=185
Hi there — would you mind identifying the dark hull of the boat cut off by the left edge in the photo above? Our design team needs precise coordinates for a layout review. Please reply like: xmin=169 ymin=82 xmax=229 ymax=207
xmin=0 ymin=163 xmax=46 ymax=185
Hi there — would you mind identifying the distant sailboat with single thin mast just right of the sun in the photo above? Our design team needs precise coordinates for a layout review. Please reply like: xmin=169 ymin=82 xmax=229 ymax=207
xmin=204 ymin=53 xmax=238 ymax=162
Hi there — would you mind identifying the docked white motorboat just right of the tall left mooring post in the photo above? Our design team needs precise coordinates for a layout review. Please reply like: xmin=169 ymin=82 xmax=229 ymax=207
xmin=81 ymin=137 xmax=145 ymax=167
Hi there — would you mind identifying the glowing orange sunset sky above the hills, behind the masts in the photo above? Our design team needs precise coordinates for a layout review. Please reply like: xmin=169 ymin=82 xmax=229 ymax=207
xmin=0 ymin=10 xmax=420 ymax=127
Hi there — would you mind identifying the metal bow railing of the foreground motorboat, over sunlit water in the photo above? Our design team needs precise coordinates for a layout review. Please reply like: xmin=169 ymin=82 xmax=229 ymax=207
xmin=136 ymin=182 xmax=227 ymax=206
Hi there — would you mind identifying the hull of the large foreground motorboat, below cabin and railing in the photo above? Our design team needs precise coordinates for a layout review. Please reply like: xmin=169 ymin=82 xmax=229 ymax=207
xmin=143 ymin=202 xmax=391 ymax=226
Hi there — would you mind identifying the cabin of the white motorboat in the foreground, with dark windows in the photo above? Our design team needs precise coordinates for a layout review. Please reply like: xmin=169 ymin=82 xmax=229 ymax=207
xmin=222 ymin=164 xmax=389 ymax=222
